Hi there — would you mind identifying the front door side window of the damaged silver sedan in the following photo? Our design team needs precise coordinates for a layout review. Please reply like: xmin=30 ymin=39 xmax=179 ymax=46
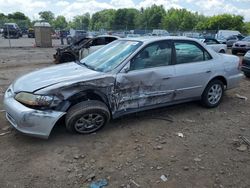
xmin=130 ymin=41 xmax=172 ymax=70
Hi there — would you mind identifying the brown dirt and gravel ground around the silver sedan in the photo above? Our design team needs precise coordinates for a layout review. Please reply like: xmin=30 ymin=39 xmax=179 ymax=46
xmin=0 ymin=44 xmax=250 ymax=188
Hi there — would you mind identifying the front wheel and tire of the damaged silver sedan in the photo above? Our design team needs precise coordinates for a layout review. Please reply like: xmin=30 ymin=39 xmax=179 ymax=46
xmin=65 ymin=100 xmax=110 ymax=134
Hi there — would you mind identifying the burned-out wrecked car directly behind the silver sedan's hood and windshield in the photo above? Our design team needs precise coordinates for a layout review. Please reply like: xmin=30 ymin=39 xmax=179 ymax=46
xmin=54 ymin=35 xmax=119 ymax=64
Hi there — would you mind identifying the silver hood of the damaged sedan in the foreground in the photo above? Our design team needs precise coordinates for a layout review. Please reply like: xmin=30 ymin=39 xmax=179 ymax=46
xmin=13 ymin=63 xmax=103 ymax=92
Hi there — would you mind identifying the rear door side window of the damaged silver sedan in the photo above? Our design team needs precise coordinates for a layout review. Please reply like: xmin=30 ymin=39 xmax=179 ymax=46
xmin=174 ymin=42 xmax=211 ymax=64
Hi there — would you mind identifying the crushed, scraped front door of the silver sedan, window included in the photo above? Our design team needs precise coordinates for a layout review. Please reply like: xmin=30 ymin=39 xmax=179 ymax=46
xmin=115 ymin=41 xmax=175 ymax=113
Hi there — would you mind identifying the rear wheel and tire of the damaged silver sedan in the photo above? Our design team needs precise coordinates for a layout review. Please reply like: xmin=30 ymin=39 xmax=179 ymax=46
xmin=201 ymin=80 xmax=224 ymax=108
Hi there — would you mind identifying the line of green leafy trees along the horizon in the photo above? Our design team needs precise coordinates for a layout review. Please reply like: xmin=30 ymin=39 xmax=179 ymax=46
xmin=0 ymin=5 xmax=250 ymax=33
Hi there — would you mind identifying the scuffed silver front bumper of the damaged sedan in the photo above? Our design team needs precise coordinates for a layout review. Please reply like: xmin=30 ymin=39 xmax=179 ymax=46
xmin=4 ymin=87 xmax=65 ymax=139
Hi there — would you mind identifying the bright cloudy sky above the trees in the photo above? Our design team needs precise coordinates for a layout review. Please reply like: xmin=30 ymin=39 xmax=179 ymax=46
xmin=0 ymin=0 xmax=250 ymax=21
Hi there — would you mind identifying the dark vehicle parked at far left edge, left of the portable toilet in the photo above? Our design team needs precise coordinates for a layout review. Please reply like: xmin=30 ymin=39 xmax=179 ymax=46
xmin=3 ymin=23 xmax=22 ymax=39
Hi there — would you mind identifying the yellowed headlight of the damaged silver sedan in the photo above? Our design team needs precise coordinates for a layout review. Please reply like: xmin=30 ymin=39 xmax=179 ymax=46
xmin=15 ymin=92 xmax=54 ymax=107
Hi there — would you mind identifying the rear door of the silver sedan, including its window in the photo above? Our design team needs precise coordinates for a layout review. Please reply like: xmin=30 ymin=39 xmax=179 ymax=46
xmin=174 ymin=40 xmax=213 ymax=100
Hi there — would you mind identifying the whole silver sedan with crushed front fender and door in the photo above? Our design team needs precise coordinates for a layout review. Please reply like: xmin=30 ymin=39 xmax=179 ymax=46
xmin=4 ymin=37 xmax=242 ymax=138
